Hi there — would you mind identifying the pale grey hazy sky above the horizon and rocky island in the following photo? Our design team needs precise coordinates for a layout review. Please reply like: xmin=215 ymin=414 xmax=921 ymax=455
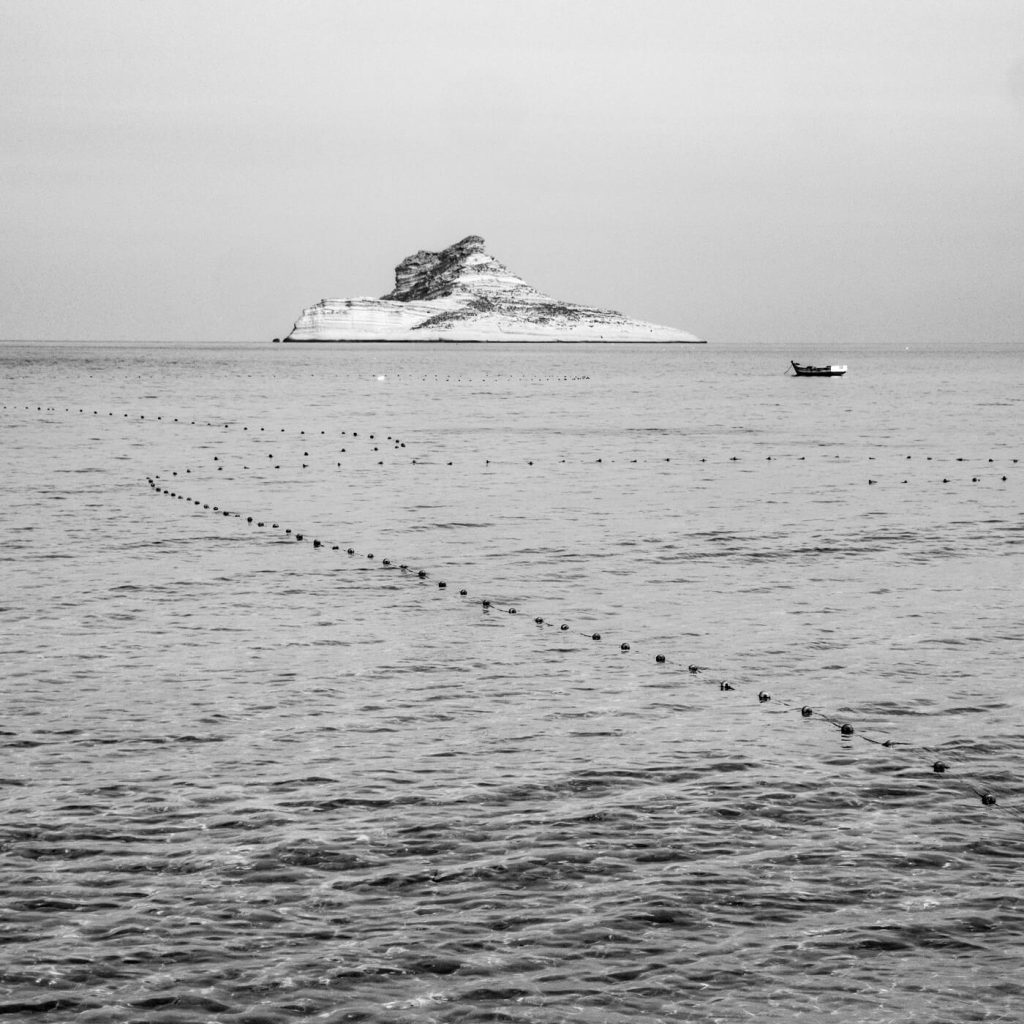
xmin=0 ymin=0 xmax=1024 ymax=344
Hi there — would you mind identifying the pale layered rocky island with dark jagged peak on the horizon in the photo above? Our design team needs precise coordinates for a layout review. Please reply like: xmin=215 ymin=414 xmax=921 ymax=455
xmin=285 ymin=234 xmax=701 ymax=344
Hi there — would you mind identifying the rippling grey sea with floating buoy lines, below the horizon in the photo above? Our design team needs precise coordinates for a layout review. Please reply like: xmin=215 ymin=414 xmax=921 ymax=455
xmin=0 ymin=339 xmax=1024 ymax=1024
